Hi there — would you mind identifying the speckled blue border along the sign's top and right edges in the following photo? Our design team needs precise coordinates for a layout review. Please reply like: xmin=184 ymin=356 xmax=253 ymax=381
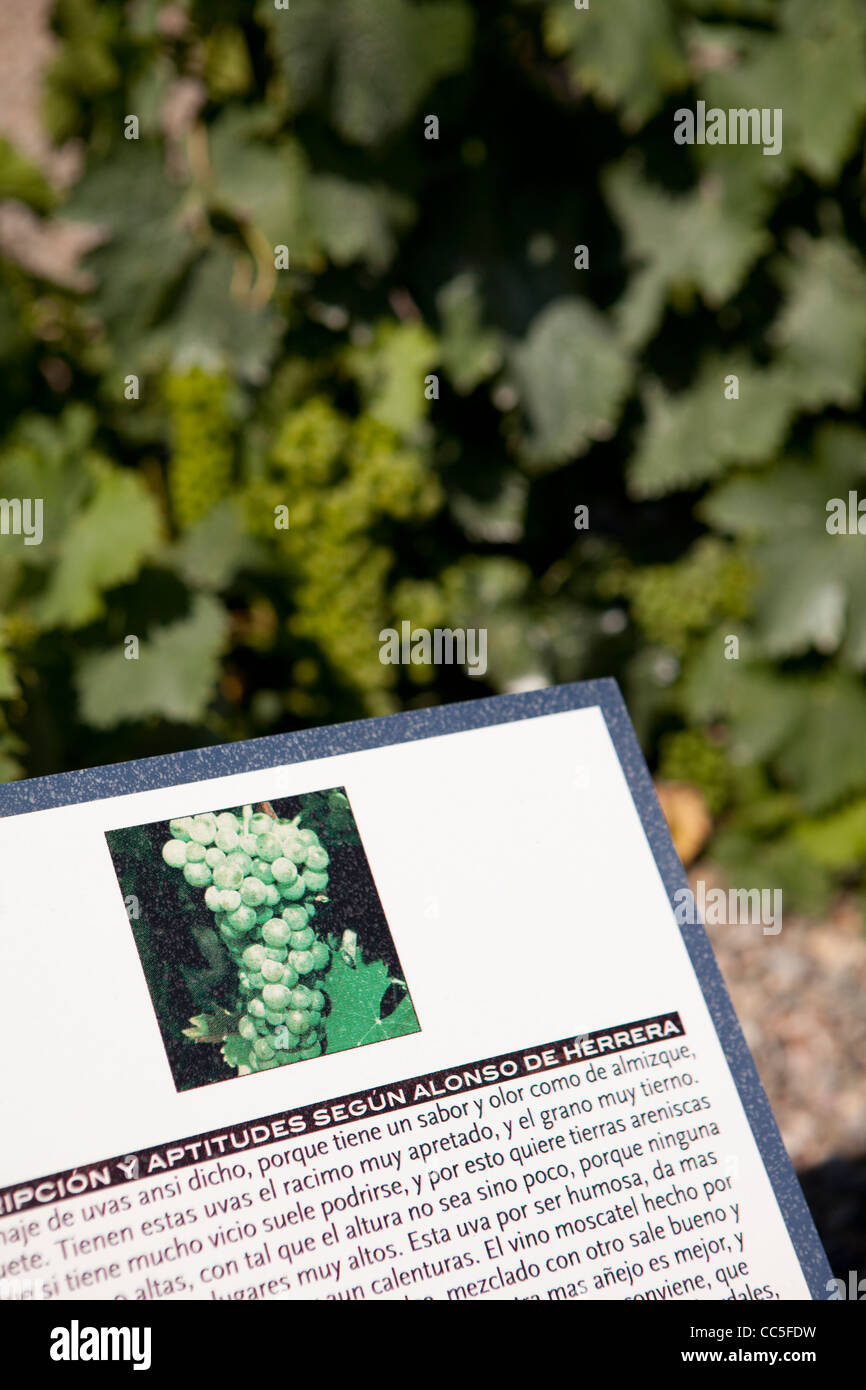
xmin=0 ymin=680 xmax=833 ymax=1300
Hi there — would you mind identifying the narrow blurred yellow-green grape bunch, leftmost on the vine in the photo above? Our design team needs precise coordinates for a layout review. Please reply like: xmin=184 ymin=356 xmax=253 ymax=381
xmin=164 ymin=367 xmax=234 ymax=530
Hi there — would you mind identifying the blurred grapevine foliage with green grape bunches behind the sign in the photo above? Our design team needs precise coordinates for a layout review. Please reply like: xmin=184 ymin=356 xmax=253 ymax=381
xmin=0 ymin=0 xmax=866 ymax=910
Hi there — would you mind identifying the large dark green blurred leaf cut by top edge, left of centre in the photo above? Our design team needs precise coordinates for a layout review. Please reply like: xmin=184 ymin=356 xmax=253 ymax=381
xmin=256 ymin=0 xmax=473 ymax=146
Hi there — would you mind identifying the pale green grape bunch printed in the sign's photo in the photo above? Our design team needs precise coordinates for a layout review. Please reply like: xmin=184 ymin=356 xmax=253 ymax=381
xmin=163 ymin=809 xmax=331 ymax=1074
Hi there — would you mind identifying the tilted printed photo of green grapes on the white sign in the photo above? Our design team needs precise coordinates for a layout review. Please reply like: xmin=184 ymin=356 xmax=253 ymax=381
xmin=106 ymin=787 xmax=420 ymax=1091
